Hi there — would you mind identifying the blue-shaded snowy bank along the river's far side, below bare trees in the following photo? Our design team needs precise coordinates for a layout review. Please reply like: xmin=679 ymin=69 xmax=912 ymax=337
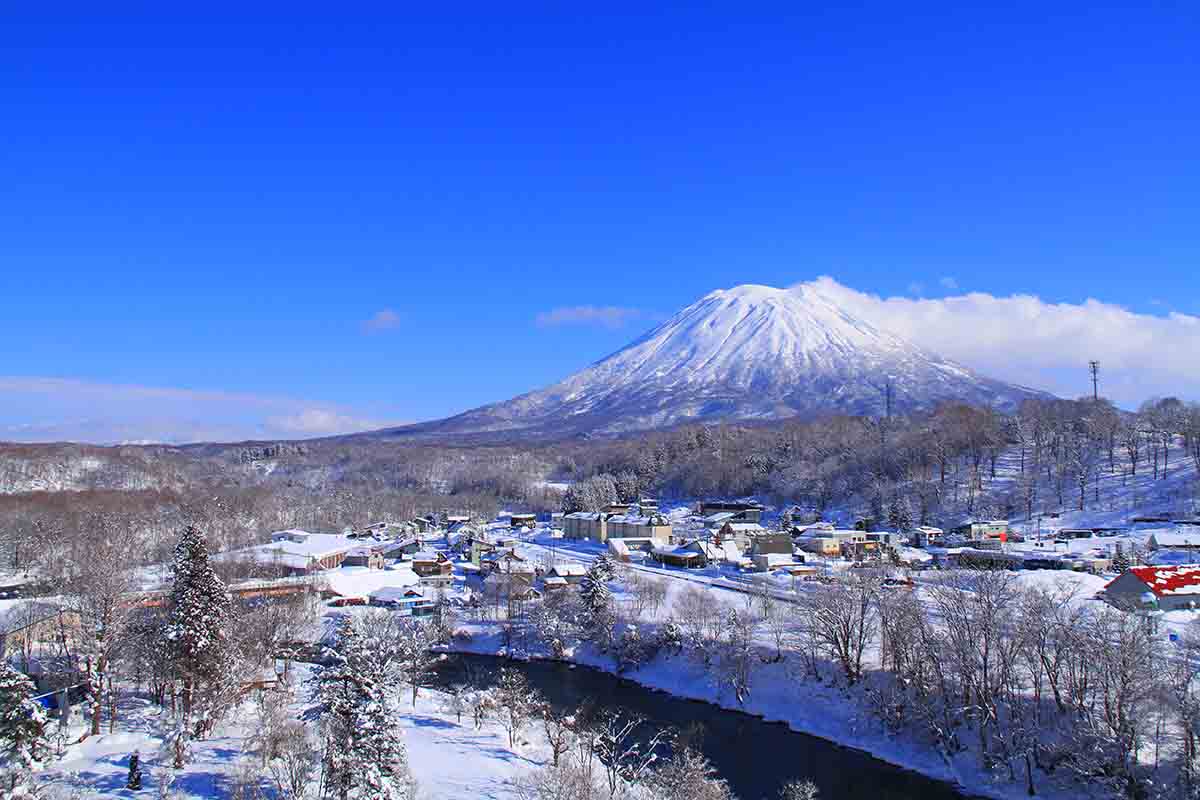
xmin=448 ymin=622 xmax=1088 ymax=800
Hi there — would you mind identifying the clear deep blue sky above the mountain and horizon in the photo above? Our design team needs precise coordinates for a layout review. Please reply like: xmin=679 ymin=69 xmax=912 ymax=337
xmin=0 ymin=2 xmax=1200 ymax=439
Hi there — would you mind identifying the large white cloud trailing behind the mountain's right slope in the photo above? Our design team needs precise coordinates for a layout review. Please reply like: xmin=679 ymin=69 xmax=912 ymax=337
xmin=808 ymin=276 xmax=1200 ymax=407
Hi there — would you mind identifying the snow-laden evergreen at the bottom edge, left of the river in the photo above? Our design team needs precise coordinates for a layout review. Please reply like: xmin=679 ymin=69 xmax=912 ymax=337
xmin=318 ymin=618 xmax=414 ymax=800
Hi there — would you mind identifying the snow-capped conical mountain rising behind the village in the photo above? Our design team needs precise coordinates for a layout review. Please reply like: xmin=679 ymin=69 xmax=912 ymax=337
xmin=398 ymin=284 xmax=1042 ymax=433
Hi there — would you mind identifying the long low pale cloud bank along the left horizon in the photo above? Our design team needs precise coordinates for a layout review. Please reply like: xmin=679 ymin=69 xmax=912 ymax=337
xmin=0 ymin=375 xmax=400 ymax=444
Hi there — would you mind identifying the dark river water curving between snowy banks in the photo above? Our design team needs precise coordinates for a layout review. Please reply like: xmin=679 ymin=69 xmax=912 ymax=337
xmin=439 ymin=655 xmax=968 ymax=800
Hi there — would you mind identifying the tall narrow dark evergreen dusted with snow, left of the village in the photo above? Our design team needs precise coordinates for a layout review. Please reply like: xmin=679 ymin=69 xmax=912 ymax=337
xmin=166 ymin=525 xmax=229 ymax=716
